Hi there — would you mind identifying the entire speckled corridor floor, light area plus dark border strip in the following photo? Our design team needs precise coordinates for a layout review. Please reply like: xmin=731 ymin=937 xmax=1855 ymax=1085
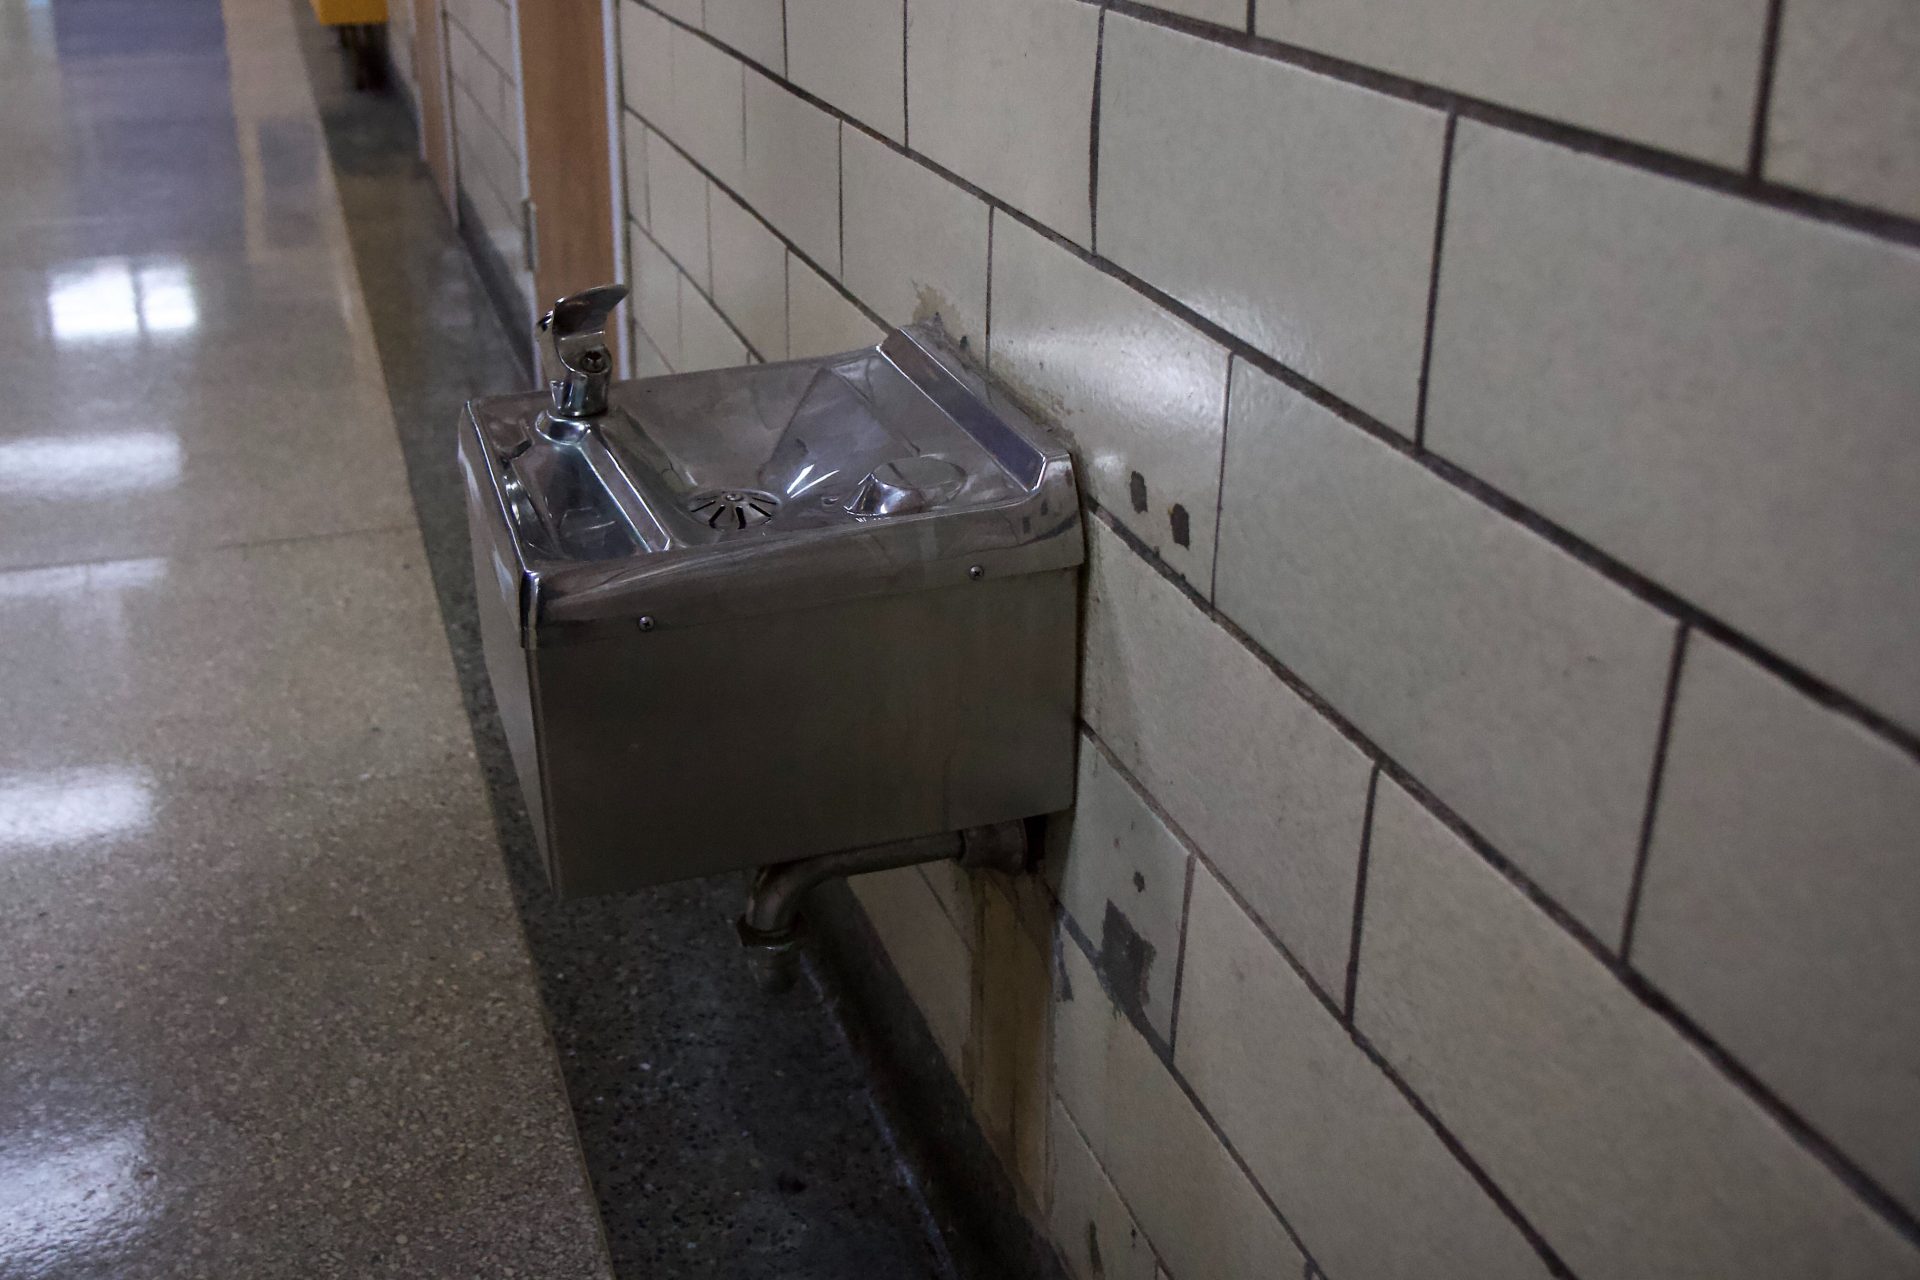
xmin=0 ymin=0 xmax=998 ymax=1280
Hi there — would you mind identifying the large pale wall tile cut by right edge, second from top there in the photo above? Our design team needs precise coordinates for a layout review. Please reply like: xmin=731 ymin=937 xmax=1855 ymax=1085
xmin=1427 ymin=125 xmax=1920 ymax=740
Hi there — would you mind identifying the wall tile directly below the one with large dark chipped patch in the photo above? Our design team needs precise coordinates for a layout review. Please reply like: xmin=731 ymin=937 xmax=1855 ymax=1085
xmin=1054 ymin=942 xmax=1304 ymax=1280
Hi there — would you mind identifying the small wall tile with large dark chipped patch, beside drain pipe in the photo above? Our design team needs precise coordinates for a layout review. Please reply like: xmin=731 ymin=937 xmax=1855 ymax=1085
xmin=1046 ymin=739 xmax=1188 ymax=1042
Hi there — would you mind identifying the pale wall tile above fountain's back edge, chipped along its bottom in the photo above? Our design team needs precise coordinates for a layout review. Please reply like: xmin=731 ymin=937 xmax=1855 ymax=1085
xmin=841 ymin=125 xmax=989 ymax=351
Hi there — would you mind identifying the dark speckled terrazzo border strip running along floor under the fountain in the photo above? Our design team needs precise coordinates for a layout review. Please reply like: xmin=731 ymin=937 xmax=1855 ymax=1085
xmin=307 ymin=14 xmax=990 ymax=1280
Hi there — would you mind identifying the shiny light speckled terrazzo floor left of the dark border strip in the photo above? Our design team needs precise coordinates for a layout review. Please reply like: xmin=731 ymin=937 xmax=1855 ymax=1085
xmin=0 ymin=0 xmax=611 ymax=1280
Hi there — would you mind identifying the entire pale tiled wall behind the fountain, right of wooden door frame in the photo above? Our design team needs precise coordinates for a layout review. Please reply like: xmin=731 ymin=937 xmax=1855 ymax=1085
xmin=602 ymin=0 xmax=1920 ymax=1280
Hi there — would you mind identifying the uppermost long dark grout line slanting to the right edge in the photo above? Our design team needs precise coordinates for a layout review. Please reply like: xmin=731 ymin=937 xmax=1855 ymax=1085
xmin=1098 ymin=0 xmax=1920 ymax=253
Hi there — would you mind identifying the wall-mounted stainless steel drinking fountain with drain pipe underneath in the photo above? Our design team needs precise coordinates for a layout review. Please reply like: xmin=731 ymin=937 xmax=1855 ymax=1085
xmin=459 ymin=286 xmax=1085 ymax=981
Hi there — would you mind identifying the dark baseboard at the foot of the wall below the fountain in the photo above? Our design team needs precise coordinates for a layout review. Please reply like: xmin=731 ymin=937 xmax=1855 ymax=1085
xmin=806 ymin=881 xmax=1066 ymax=1280
